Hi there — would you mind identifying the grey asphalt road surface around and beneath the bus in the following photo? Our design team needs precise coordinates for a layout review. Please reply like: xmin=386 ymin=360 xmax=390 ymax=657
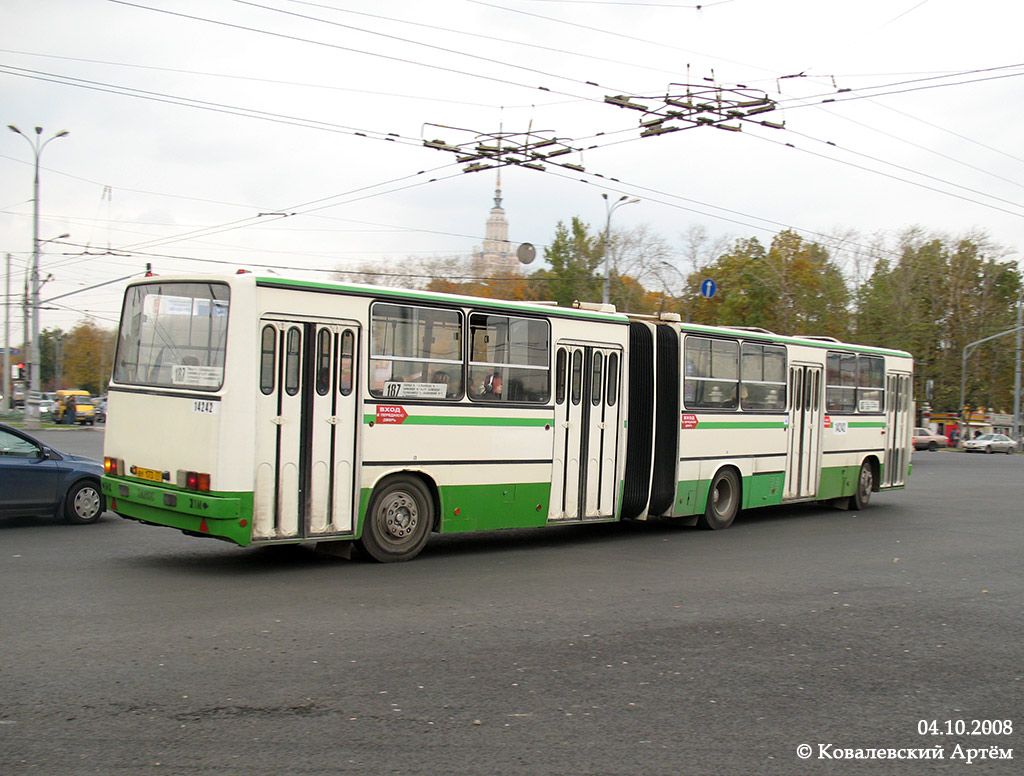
xmin=0 ymin=430 xmax=1024 ymax=776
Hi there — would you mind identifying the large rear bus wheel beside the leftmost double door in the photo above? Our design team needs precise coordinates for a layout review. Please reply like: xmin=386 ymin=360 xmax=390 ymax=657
xmin=358 ymin=474 xmax=434 ymax=563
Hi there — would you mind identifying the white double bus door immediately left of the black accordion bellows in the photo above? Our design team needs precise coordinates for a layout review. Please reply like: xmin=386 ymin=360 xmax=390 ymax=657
xmin=548 ymin=342 xmax=622 ymax=521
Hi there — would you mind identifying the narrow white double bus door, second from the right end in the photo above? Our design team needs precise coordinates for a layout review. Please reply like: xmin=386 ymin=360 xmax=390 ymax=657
xmin=782 ymin=364 xmax=824 ymax=499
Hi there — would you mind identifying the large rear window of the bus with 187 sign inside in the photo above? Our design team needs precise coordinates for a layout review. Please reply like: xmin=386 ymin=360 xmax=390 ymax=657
xmin=114 ymin=283 xmax=229 ymax=391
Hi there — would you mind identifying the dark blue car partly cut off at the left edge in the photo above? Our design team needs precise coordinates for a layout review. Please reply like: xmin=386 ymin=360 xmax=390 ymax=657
xmin=0 ymin=423 xmax=106 ymax=524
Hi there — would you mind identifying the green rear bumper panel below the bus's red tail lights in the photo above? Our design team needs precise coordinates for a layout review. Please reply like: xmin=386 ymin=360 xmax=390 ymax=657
xmin=100 ymin=475 xmax=253 ymax=547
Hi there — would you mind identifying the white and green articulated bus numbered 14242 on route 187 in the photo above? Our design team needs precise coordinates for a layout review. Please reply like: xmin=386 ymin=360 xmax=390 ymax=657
xmin=102 ymin=273 xmax=913 ymax=562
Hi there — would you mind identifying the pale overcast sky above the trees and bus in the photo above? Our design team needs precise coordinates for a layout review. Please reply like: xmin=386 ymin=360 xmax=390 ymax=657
xmin=0 ymin=0 xmax=1024 ymax=341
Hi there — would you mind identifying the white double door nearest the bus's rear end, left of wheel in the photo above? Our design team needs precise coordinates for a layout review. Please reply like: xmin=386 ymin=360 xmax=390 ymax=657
xmin=253 ymin=318 xmax=359 ymax=541
